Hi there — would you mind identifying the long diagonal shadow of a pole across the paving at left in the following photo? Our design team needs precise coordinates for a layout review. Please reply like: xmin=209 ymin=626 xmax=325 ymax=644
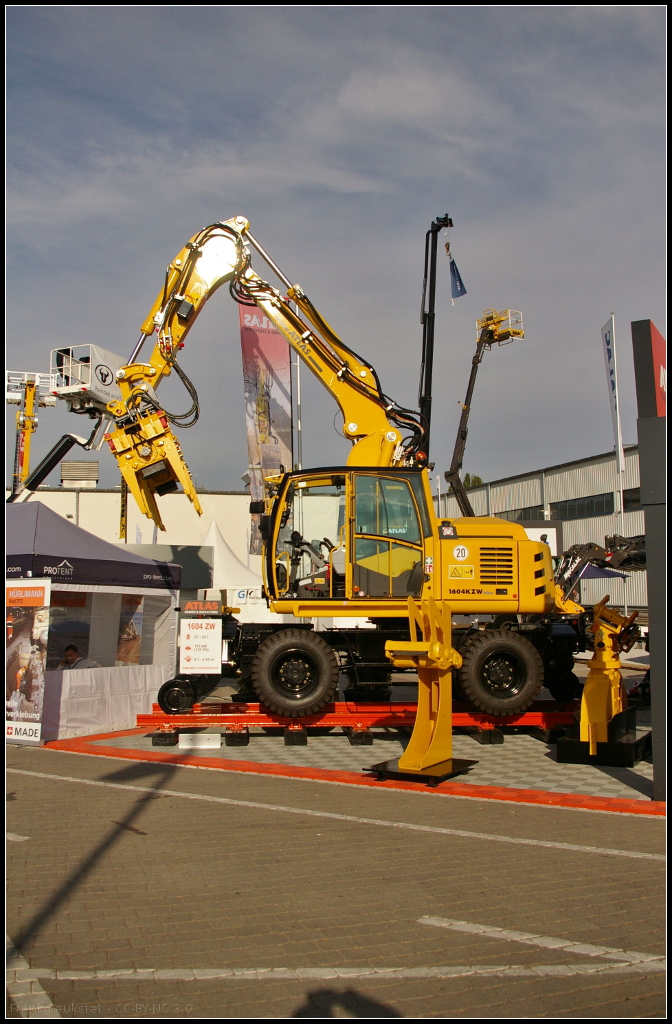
xmin=13 ymin=763 xmax=180 ymax=953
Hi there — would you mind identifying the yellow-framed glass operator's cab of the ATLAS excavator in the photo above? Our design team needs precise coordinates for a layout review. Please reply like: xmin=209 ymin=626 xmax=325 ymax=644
xmin=262 ymin=468 xmax=431 ymax=614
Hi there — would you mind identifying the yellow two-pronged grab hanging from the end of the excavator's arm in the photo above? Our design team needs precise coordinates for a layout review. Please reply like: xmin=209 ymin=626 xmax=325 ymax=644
xmin=104 ymin=402 xmax=203 ymax=530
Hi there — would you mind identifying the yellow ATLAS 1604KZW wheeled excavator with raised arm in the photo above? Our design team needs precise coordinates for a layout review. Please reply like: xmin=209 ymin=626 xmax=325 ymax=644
xmin=14 ymin=216 xmax=635 ymax=775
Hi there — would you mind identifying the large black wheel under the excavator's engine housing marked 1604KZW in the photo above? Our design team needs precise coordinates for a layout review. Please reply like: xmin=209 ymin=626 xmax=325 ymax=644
xmin=457 ymin=630 xmax=544 ymax=716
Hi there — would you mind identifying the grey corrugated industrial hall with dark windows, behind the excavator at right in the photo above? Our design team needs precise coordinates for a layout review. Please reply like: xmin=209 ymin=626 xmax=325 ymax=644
xmin=434 ymin=444 xmax=647 ymax=609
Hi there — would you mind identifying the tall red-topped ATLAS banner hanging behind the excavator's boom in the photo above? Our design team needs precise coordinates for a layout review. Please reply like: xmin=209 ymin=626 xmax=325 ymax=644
xmin=238 ymin=305 xmax=293 ymax=555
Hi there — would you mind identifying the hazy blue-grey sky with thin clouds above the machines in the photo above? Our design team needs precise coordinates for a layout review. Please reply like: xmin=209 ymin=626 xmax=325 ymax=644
xmin=5 ymin=5 xmax=666 ymax=490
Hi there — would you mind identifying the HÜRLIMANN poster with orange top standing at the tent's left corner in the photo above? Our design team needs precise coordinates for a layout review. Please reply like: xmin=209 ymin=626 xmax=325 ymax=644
xmin=5 ymin=580 xmax=51 ymax=743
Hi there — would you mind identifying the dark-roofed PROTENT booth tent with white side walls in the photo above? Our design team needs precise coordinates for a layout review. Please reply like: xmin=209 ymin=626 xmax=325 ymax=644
xmin=5 ymin=502 xmax=181 ymax=741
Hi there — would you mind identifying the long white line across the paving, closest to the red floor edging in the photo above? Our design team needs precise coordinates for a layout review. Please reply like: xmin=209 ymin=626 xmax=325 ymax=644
xmin=7 ymin=768 xmax=666 ymax=861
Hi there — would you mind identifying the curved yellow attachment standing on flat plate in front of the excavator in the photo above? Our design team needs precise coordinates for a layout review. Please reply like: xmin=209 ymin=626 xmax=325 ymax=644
xmin=385 ymin=597 xmax=462 ymax=771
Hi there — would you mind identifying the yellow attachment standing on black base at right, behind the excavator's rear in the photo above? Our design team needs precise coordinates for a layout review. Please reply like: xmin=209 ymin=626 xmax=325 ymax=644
xmin=580 ymin=595 xmax=638 ymax=756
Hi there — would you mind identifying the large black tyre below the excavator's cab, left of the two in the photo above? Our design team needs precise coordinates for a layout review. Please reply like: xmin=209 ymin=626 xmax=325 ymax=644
xmin=250 ymin=630 xmax=339 ymax=718
